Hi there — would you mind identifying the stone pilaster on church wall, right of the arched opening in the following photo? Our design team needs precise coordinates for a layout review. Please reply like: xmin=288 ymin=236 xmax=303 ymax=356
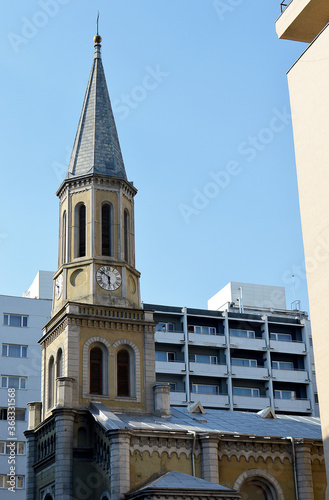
xmin=295 ymin=442 xmax=314 ymax=500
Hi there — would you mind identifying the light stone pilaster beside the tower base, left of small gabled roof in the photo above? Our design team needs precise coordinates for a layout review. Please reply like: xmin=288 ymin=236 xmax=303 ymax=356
xmin=109 ymin=431 xmax=130 ymax=500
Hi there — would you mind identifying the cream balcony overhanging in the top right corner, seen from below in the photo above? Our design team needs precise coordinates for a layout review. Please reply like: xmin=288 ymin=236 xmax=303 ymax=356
xmin=276 ymin=0 xmax=329 ymax=43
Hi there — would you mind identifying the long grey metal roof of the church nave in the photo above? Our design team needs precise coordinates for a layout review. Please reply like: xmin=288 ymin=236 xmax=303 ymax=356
xmin=89 ymin=402 xmax=322 ymax=440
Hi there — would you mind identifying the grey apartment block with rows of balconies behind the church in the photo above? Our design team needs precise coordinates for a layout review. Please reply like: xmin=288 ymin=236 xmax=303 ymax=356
xmin=143 ymin=282 xmax=319 ymax=416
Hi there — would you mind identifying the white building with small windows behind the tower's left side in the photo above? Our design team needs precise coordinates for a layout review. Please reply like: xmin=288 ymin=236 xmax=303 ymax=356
xmin=0 ymin=271 xmax=52 ymax=500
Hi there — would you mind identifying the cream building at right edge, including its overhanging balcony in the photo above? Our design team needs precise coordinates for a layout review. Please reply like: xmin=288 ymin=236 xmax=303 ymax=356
xmin=276 ymin=0 xmax=329 ymax=475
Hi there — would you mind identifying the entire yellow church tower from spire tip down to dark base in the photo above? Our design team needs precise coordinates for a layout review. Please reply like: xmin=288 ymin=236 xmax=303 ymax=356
xmin=26 ymin=34 xmax=155 ymax=500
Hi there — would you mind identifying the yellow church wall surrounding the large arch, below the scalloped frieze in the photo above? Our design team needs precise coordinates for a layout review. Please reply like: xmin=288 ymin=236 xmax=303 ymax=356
xmin=219 ymin=456 xmax=295 ymax=500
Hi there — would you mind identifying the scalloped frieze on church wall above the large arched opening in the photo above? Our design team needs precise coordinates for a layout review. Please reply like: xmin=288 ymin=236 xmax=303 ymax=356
xmin=218 ymin=441 xmax=292 ymax=464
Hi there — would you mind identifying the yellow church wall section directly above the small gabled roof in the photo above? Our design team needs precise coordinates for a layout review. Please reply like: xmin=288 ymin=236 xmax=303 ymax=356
xmin=130 ymin=450 xmax=201 ymax=488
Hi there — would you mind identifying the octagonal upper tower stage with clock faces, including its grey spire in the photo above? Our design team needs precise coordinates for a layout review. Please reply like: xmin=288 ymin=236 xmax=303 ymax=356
xmin=53 ymin=35 xmax=140 ymax=315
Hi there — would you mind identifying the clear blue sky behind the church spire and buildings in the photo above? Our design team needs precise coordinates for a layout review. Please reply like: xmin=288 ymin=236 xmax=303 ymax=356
xmin=0 ymin=0 xmax=308 ymax=310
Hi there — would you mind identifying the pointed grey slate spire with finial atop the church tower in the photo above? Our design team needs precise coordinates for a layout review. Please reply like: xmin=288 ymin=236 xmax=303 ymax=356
xmin=66 ymin=28 xmax=127 ymax=179
